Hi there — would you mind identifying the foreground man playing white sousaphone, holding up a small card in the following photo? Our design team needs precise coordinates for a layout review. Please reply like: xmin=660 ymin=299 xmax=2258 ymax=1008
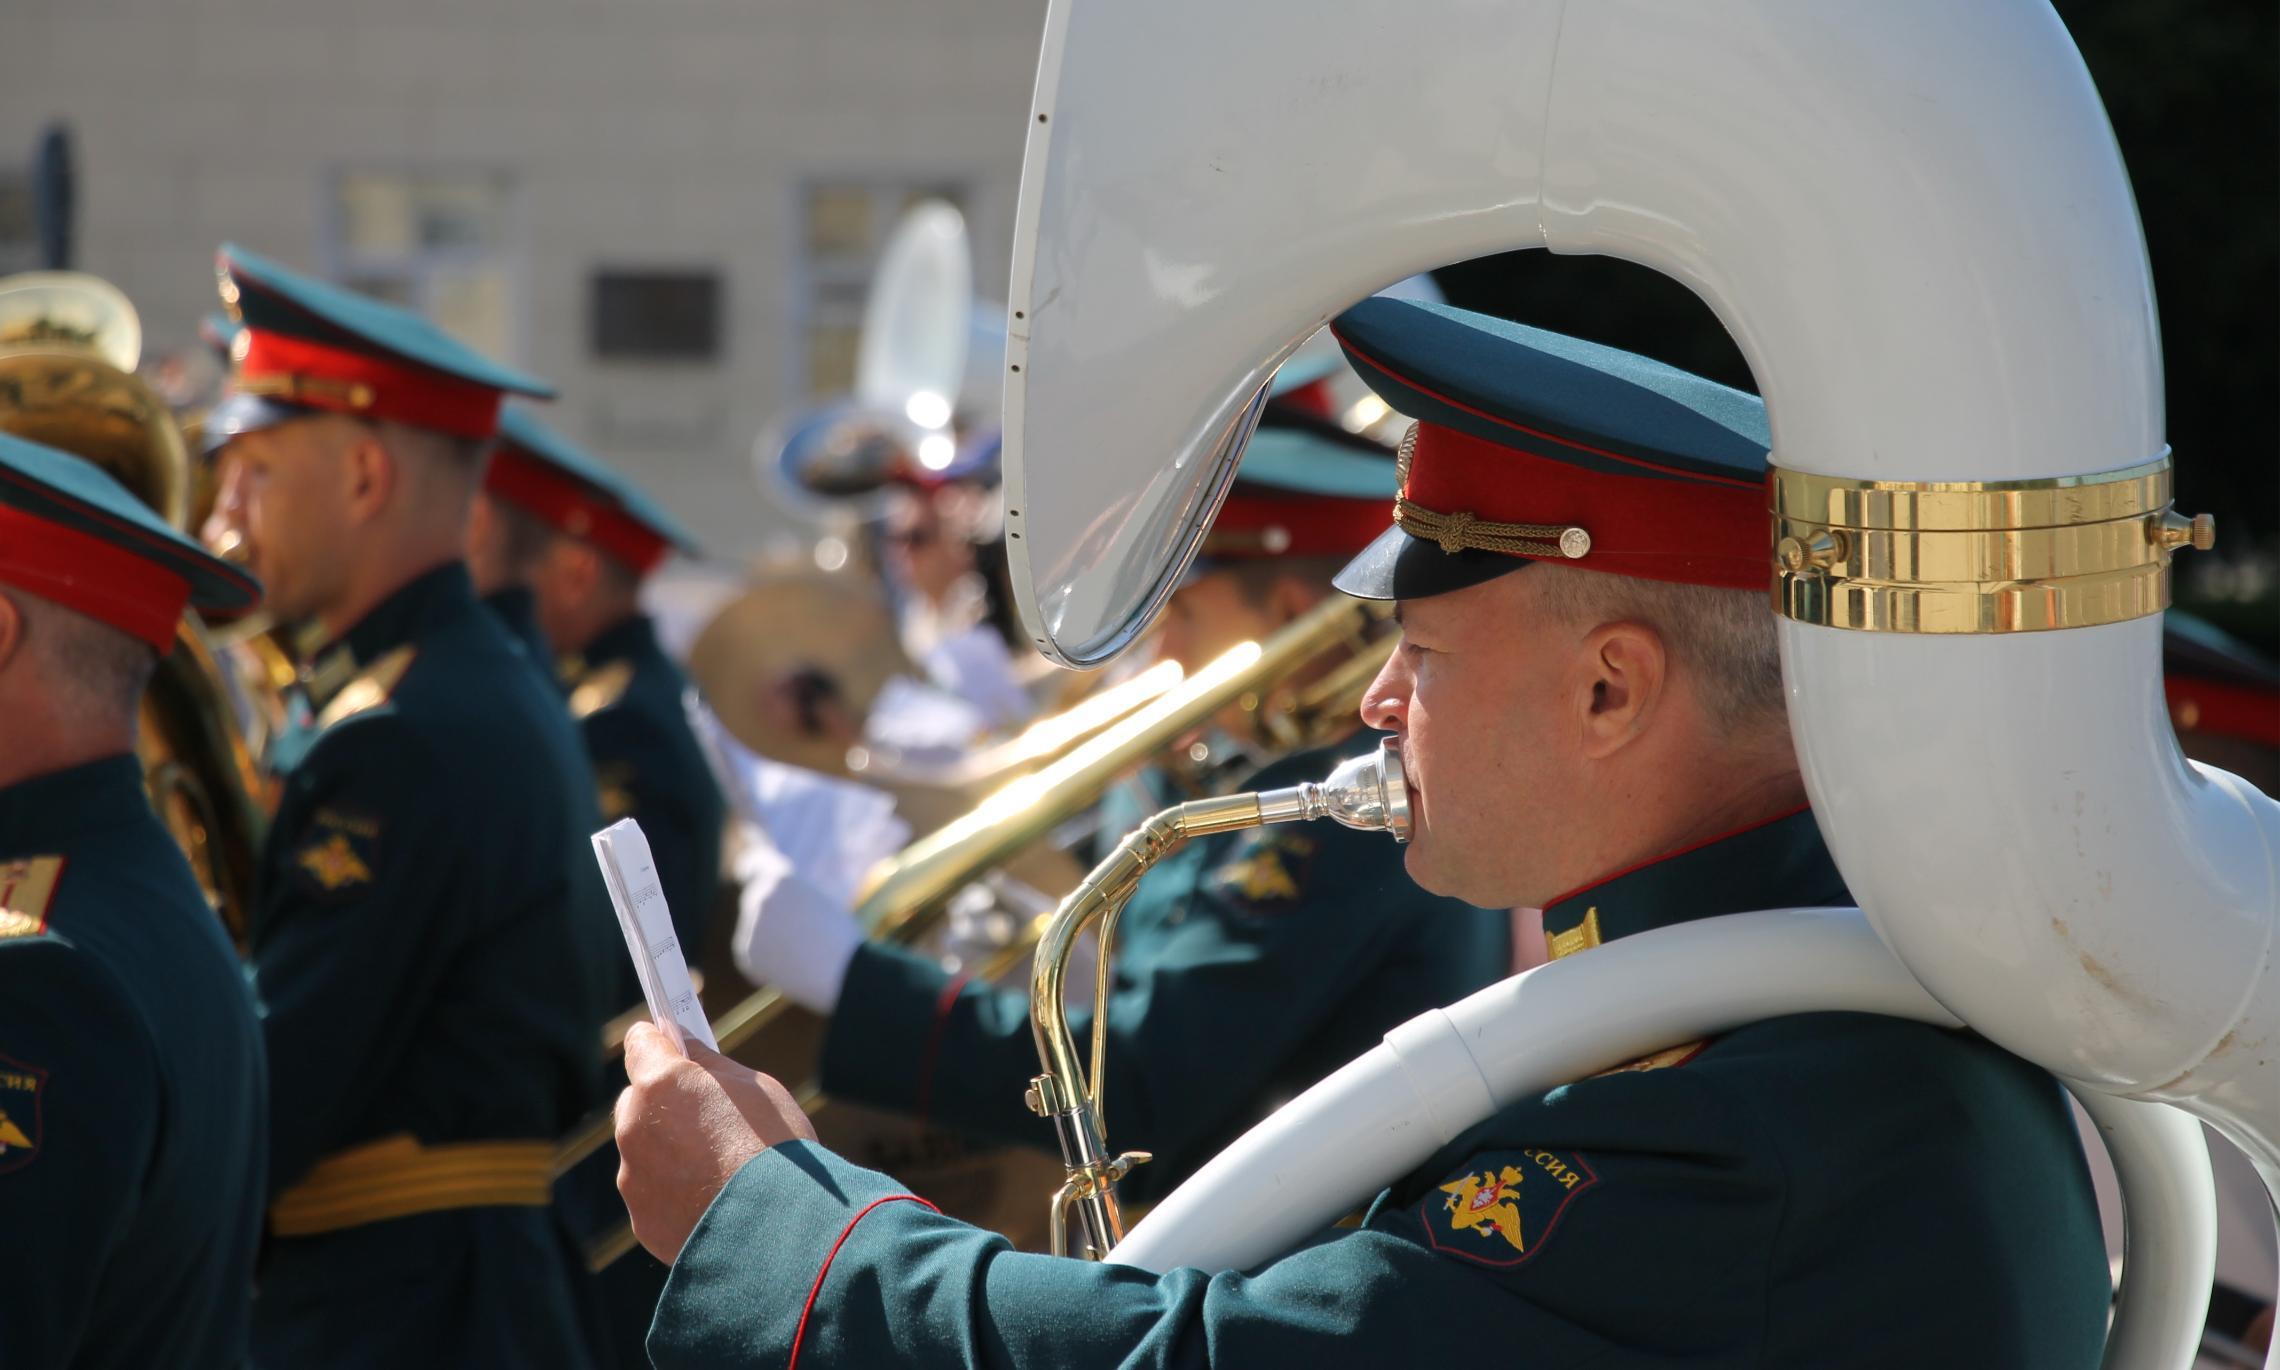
xmin=618 ymin=301 xmax=2109 ymax=1370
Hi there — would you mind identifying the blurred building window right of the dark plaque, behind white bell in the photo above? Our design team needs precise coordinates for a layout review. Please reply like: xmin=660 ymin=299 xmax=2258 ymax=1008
xmin=791 ymin=180 xmax=969 ymax=399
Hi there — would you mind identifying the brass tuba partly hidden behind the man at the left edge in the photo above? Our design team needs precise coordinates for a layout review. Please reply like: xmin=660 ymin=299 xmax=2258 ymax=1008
xmin=0 ymin=271 xmax=264 ymax=941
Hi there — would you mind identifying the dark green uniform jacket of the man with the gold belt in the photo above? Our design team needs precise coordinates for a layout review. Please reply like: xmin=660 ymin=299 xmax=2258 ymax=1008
xmin=253 ymin=563 xmax=625 ymax=1365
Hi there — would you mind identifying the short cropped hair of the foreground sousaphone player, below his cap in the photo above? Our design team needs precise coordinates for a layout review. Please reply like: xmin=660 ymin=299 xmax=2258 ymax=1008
xmin=1528 ymin=563 xmax=1788 ymax=736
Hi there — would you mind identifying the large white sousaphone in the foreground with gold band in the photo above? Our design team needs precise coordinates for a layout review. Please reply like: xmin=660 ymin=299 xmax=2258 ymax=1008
xmin=1005 ymin=0 xmax=2280 ymax=1368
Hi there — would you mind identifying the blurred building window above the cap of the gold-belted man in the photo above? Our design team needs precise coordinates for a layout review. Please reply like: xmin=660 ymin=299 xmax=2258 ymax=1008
xmin=324 ymin=166 xmax=515 ymax=358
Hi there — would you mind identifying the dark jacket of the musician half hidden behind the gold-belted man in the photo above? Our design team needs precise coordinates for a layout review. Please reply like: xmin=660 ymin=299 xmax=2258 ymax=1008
xmin=563 ymin=613 xmax=727 ymax=989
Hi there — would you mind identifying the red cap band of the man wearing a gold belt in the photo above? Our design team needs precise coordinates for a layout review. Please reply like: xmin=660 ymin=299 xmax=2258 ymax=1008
xmin=230 ymin=328 xmax=504 ymax=438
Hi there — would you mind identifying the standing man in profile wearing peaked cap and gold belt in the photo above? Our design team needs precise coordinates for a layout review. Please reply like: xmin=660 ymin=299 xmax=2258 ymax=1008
xmin=207 ymin=246 xmax=606 ymax=1368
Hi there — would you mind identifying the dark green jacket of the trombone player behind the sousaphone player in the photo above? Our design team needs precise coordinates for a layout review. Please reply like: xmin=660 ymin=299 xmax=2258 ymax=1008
xmin=823 ymin=732 xmax=1512 ymax=1201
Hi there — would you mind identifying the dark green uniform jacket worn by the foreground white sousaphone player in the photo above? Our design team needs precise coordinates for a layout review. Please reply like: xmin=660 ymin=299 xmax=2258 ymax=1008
xmin=650 ymin=814 xmax=2109 ymax=1370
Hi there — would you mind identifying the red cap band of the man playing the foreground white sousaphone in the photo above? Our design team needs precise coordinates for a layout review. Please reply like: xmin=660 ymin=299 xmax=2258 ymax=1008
xmin=1402 ymin=424 xmax=1774 ymax=590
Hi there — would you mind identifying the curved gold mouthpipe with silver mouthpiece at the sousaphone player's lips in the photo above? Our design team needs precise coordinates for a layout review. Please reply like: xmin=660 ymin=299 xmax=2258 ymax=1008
xmin=1028 ymin=739 xmax=1409 ymax=1261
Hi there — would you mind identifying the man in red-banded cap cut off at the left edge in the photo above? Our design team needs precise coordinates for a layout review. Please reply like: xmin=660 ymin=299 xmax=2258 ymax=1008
xmin=0 ymin=435 xmax=269 ymax=1365
